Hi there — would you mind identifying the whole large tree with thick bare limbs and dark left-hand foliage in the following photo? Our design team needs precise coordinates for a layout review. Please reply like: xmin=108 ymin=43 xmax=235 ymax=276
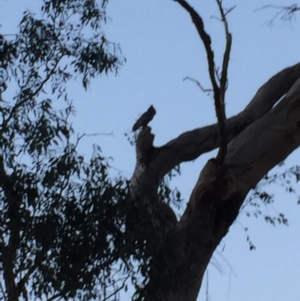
xmin=0 ymin=0 xmax=300 ymax=301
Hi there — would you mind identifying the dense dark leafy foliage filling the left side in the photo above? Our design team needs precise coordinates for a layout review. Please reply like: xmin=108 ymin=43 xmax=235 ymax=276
xmin=0 ymin=0 xmax=138 ymax=300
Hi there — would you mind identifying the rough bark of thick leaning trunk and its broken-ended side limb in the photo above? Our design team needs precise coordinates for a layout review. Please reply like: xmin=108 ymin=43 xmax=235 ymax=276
xmin=131 ymin=64 xmax=300 ymax=301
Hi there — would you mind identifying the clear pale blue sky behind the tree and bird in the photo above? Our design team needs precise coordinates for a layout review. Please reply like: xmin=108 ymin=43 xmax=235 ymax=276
xmin=0 ymin=0 xmax=300 ymax=301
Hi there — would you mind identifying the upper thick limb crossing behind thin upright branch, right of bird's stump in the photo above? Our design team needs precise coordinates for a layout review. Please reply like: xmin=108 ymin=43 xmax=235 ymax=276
xmin=151 ymin=63 xmax=300 ymax=180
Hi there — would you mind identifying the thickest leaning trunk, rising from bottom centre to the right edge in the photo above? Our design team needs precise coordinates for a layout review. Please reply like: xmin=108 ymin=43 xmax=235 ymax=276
xmin=145 ymin=67 xmax=300 ymax=301
